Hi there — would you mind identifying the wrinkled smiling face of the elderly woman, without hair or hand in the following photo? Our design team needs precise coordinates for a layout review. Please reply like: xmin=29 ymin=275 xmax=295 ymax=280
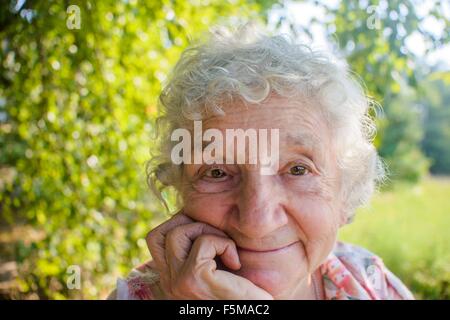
xmin=181 ymin=96 xmax=344 ymax=296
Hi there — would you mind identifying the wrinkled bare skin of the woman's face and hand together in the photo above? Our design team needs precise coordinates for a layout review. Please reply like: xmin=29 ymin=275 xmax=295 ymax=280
xmin=147 ymin=96 xmax=345 ymax=299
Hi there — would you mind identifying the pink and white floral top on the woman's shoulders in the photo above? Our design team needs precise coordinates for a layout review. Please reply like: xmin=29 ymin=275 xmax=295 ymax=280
xmin=109 ymin=242 xmax=414 ymax=300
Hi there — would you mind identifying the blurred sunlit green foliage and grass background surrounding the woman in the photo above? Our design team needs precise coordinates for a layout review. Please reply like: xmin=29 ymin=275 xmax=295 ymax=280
xmin=0 ymin=0 xmax=450 ymax=299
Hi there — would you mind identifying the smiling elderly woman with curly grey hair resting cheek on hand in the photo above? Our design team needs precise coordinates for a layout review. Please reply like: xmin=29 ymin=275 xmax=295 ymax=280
xmin=110 ymin=26 xmax=413 ymax=299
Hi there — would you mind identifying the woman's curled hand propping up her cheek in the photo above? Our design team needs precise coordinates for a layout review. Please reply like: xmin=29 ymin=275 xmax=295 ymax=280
xmin=147 ymin=213 xmax=273 ymax=300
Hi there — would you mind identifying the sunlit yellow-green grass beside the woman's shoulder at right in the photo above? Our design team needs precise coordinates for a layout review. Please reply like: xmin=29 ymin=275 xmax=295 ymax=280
xmin=339 ymin=177 xmax=450 ymax=299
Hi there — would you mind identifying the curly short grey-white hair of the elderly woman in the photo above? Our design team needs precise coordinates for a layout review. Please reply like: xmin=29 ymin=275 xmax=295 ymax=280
xmin=147 ymin=25 xmax=385 ymax=221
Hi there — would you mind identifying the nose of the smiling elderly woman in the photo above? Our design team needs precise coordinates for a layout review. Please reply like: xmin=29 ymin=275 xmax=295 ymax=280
xmin=235 ymin=174 xmax=288 ymax=238
